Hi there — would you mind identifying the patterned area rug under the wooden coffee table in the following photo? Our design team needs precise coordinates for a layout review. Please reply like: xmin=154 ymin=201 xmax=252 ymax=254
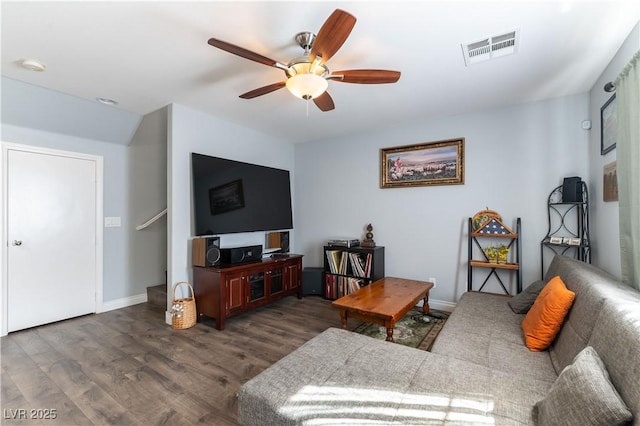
xmin=353 ymin=308 xmax=449 ymax=351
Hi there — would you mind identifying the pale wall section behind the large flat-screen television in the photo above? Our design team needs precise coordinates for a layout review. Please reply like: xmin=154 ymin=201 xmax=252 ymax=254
xmin=167 ymin=104 xmax=297 ymax=307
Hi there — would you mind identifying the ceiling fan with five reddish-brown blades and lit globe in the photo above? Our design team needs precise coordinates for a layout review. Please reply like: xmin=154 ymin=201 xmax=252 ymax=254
xmin=208 ymin=9 xmax=400 ymax=111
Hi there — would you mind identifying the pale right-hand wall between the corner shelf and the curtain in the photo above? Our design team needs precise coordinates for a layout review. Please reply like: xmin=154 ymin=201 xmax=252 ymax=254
xmin=588 ymin=24 xmax=640 ymax=278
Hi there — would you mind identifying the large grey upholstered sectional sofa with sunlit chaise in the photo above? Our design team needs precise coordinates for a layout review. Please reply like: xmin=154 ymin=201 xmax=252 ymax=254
xmin=238 ymin=256 xmax=640 ymax=426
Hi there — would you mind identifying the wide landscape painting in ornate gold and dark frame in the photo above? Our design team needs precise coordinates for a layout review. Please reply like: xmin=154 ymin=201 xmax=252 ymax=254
xmin=380 ymin=138 xmax=464 ymax=188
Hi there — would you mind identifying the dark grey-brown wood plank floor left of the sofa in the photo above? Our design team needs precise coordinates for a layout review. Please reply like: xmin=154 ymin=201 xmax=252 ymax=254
xmin=0 ymin=296 xmax=344 ymax=425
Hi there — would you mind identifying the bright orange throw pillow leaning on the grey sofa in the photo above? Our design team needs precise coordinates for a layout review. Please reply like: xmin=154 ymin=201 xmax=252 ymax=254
xmin=522 ymin=277 xmax=576 ymax=352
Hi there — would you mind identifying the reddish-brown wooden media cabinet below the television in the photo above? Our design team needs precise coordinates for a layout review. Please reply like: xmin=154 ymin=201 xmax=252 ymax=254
xmin=193 ymin=254 xmax=302 ymax=330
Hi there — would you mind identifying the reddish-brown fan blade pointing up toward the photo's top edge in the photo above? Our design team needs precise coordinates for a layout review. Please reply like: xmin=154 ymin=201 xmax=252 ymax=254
xmin=310 ymin=9 xmax=356 ymax=63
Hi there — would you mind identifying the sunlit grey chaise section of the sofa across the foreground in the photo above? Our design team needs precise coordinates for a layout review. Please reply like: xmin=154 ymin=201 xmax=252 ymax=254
xmin=238 ymin=328 xmax=551 ymax=426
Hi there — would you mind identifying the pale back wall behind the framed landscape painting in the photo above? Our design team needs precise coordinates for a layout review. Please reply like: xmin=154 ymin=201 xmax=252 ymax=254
xmin=295 ymin=94 xmax=589 ymax=302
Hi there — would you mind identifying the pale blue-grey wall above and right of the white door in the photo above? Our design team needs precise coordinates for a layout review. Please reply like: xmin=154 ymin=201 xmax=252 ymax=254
xmin=2 ymin=123 xmax=131 ymax=306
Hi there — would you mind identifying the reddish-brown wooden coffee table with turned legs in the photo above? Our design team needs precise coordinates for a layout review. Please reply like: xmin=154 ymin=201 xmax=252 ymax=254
xmin=331 ymin=277 xmax=433 ymax=342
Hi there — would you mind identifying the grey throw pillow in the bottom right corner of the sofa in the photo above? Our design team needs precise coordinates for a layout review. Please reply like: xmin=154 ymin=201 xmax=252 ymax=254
xmin=535 ymin=346 xmax=632 ymax=426
